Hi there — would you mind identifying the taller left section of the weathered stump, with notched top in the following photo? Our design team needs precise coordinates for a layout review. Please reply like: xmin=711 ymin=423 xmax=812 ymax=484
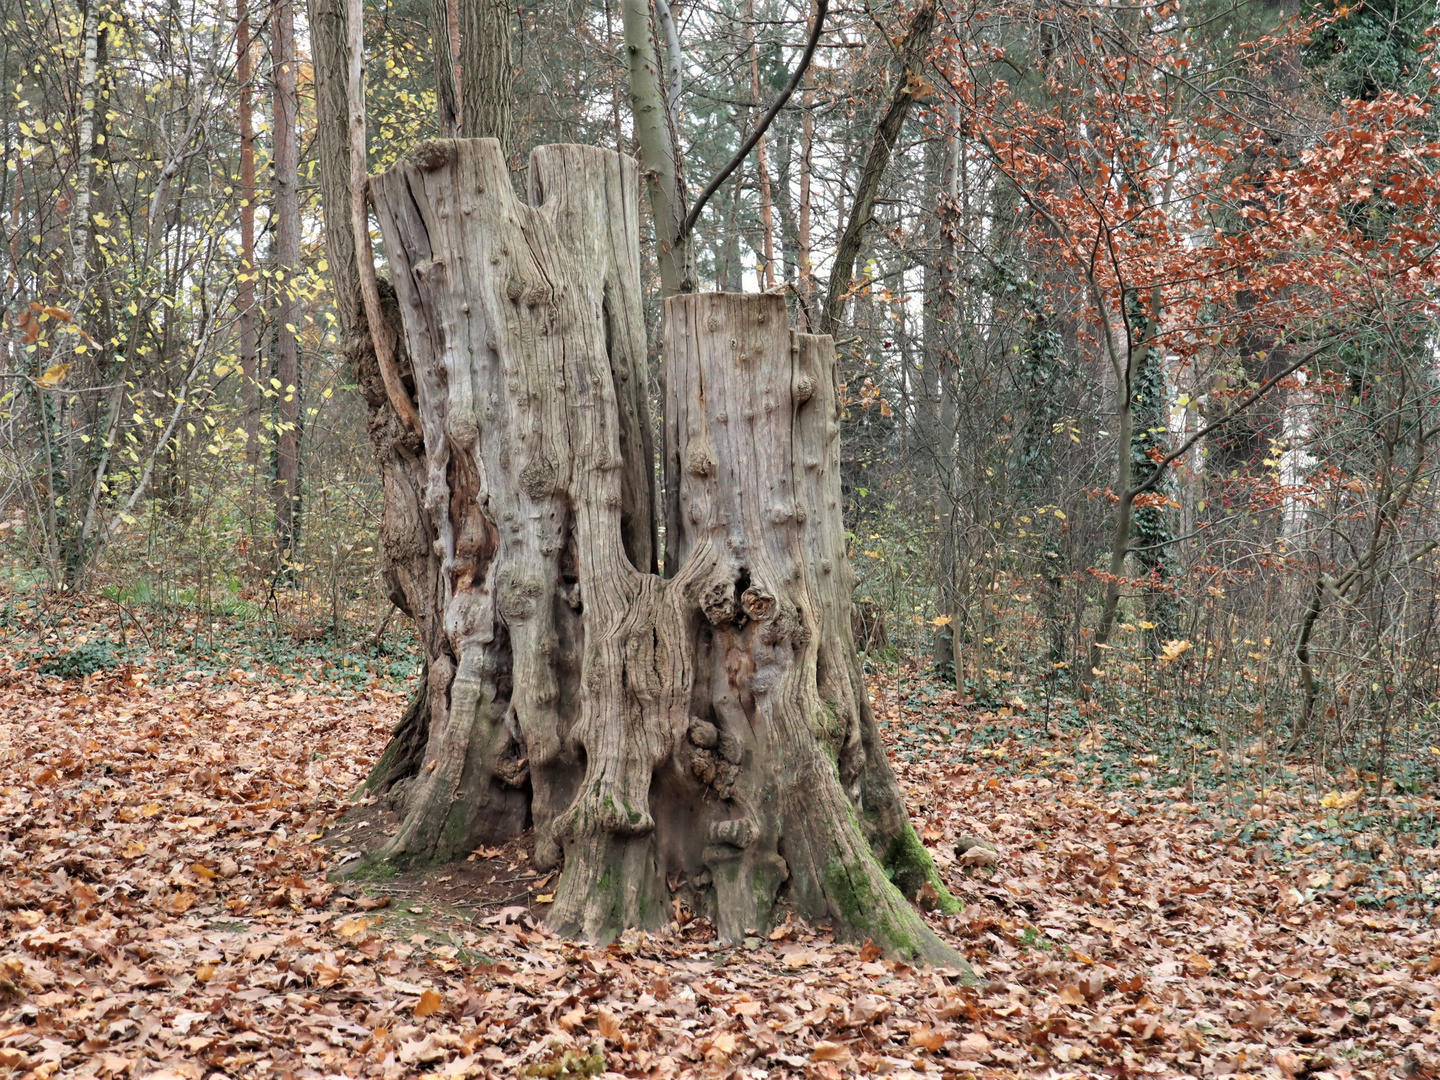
xmin=372 ymin=140 xmax=655 ymax=865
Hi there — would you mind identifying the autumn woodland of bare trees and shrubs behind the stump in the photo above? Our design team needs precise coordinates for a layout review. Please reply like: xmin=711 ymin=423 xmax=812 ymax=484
xmin=0 ymin=0 xmax=1440 ymax=789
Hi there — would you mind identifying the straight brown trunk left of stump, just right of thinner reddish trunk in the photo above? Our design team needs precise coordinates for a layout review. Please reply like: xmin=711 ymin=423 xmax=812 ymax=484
xmin=272 ymin=0 xmax=301 ymax=566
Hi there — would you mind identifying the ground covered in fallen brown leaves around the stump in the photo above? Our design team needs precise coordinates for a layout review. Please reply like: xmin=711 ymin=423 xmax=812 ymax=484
xmin=0 ymin=596 xmax=1440 ymax=1080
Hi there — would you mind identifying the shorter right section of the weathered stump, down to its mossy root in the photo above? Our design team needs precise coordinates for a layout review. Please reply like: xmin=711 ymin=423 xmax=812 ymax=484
xmin=665 ymin=294 xmax=950 ymax=958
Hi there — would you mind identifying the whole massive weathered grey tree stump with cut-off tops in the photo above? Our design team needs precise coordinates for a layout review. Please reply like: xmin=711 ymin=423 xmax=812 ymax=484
xmin=372 ymin=140 xmax=960 ymax=963
